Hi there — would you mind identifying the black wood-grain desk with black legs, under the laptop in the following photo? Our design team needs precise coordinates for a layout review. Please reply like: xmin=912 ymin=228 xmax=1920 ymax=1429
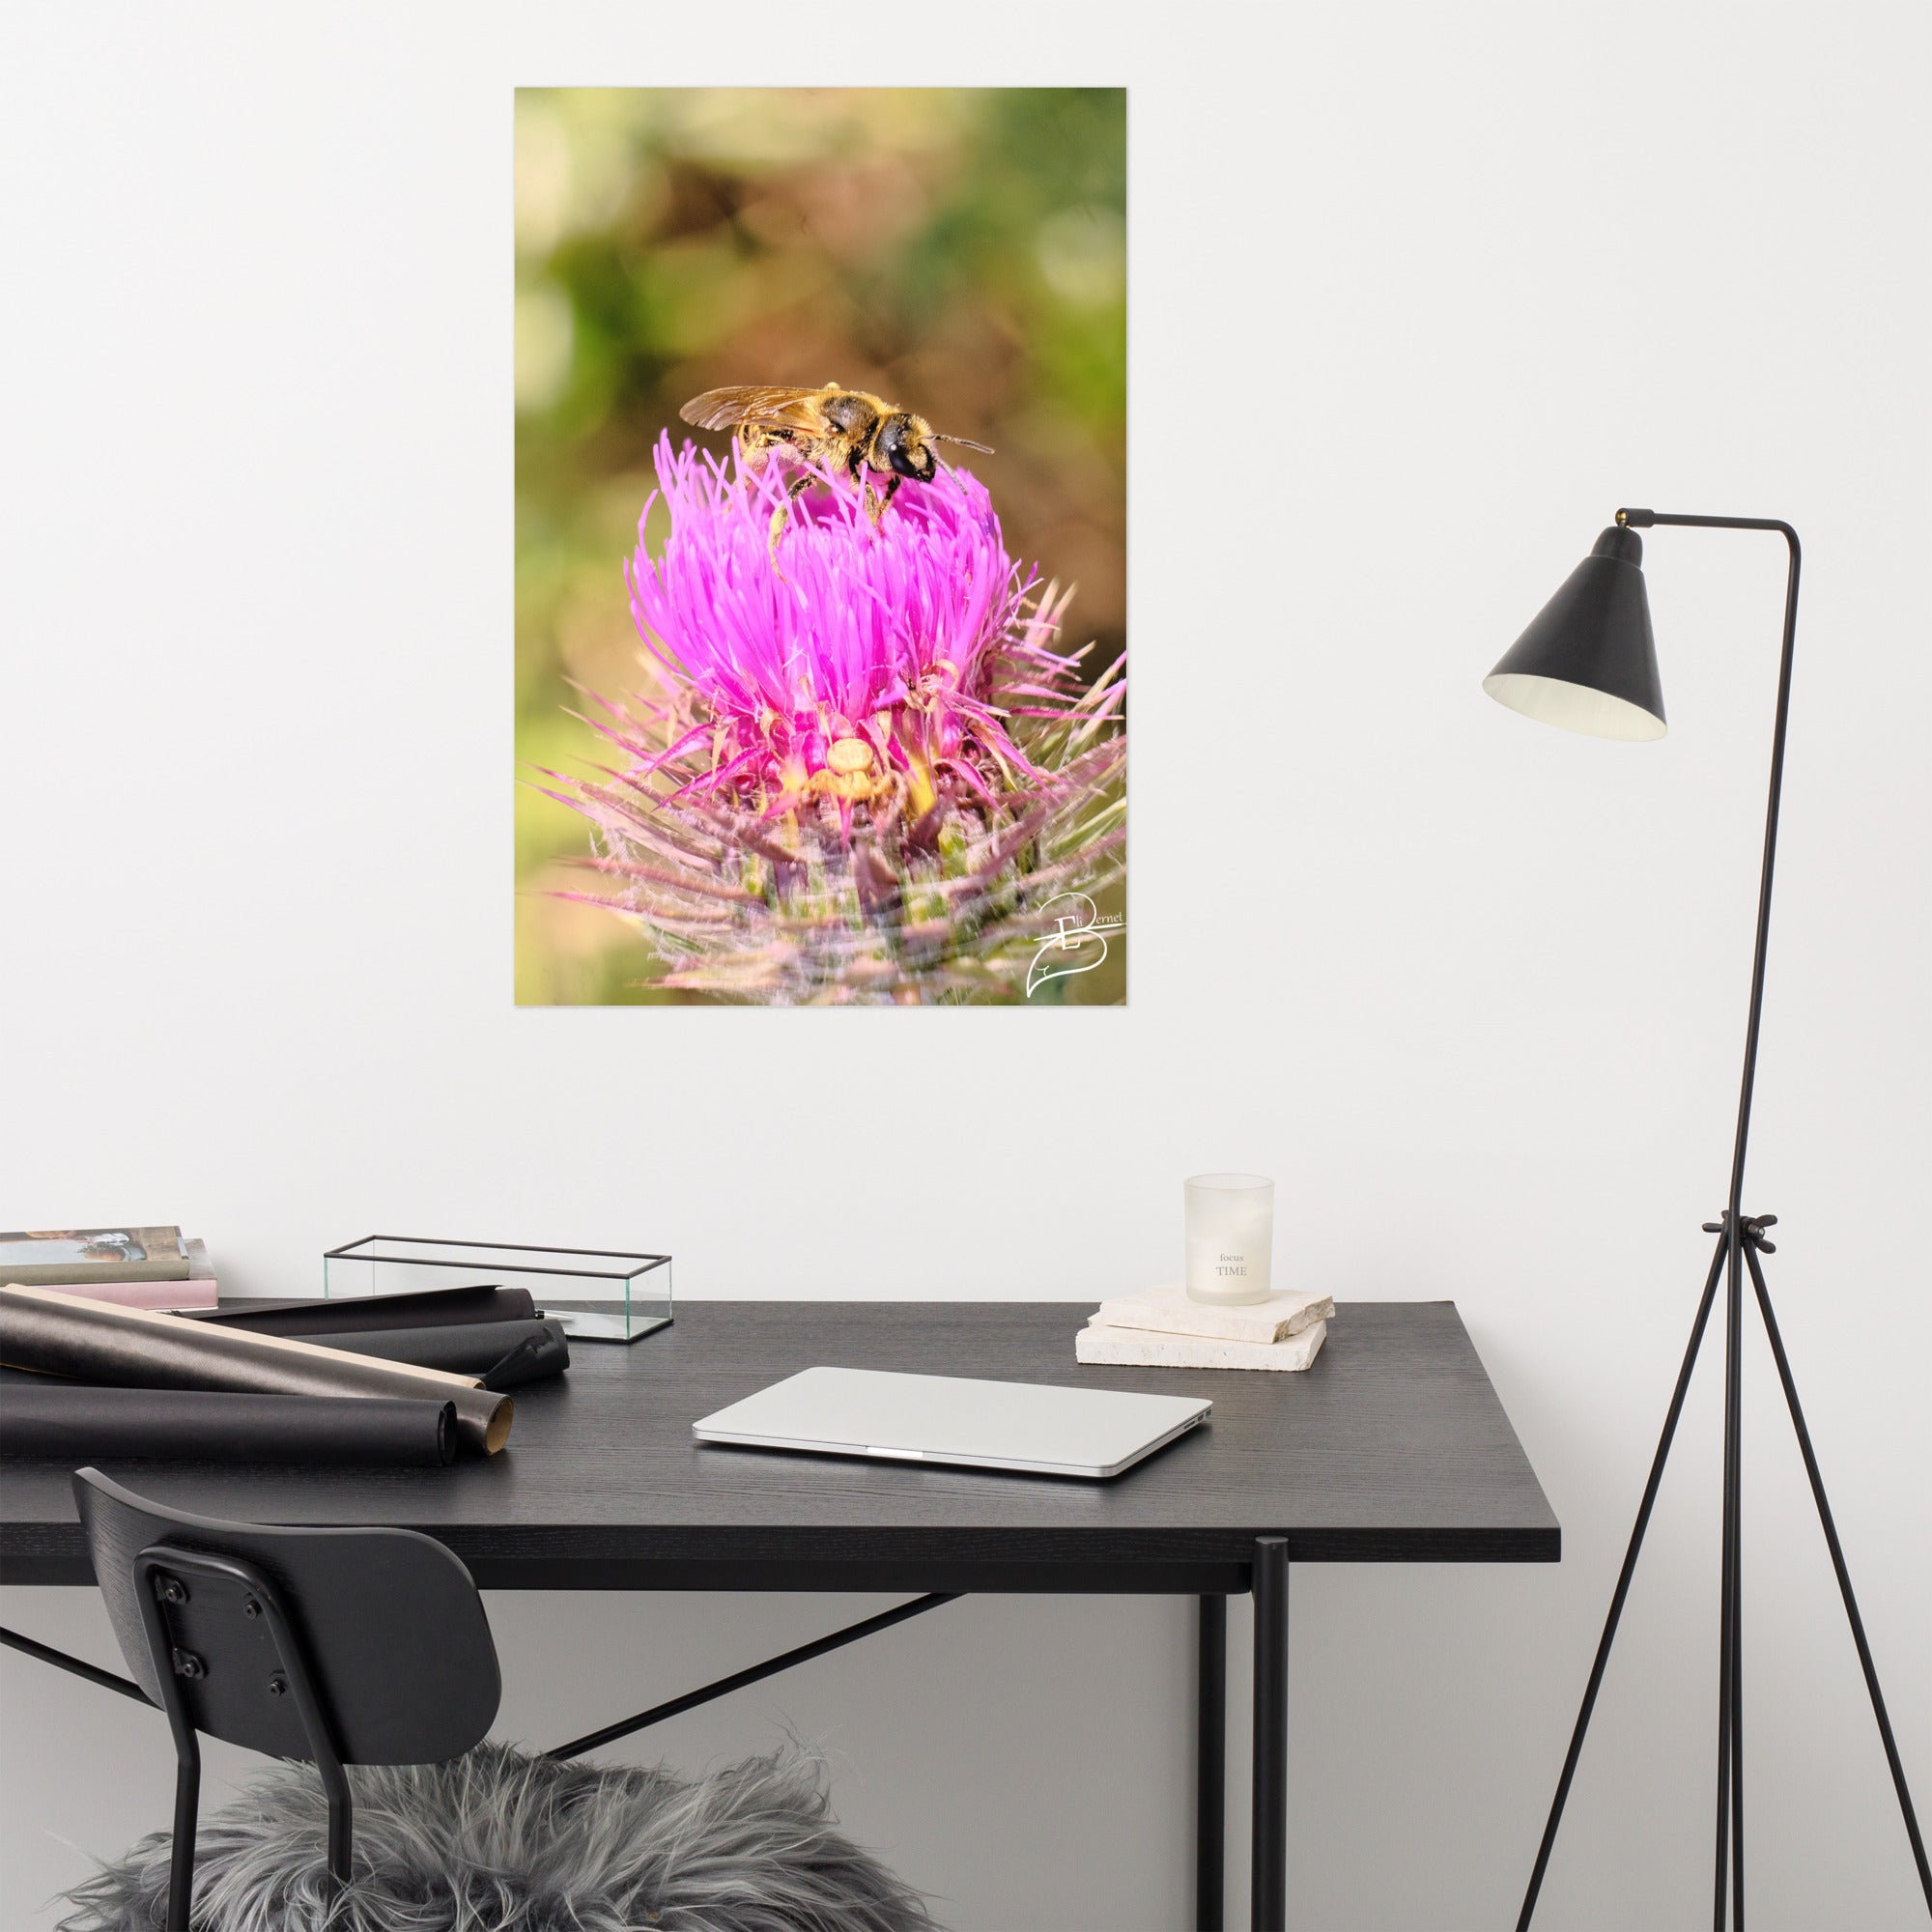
xmin=0 ymin=1302 xmax=1561 ymax=1932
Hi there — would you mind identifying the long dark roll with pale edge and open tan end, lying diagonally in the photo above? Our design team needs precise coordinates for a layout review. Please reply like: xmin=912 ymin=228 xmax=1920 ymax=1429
xmin=0 ymin=1285 xmax=516 ymax=1455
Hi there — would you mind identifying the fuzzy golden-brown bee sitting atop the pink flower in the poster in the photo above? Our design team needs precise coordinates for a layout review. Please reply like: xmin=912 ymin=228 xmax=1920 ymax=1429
xmin=678 ymin=383 xmax=993 ymax=551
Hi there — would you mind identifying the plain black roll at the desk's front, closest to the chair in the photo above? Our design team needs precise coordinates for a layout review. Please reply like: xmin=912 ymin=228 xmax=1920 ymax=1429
xmin=0 ymin=1378 xmax=456 ymax=1468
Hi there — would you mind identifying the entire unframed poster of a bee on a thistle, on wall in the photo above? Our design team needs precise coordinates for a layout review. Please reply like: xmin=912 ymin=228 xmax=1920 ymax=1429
xmin=516 ymin=89 xmax=1126 ymax=1007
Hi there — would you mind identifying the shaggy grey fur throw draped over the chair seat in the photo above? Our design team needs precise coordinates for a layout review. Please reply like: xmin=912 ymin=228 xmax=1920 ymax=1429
xmin=60 ymin=1745 xmax=933 ymax=1932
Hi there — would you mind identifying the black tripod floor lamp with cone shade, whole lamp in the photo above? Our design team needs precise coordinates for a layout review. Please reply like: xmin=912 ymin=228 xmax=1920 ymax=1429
xmin=1482 ymin=510 xmax=1932 ymax=1932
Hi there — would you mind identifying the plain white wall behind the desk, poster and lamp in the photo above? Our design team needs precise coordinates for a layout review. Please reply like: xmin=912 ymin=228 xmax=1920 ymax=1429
xmin=0 ymin=0 xmax=1932 ymax=1928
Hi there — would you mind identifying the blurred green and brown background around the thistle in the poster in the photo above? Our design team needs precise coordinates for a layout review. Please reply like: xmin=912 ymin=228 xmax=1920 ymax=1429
xmin=516 ymin=89 xmax=1126 ymax=1005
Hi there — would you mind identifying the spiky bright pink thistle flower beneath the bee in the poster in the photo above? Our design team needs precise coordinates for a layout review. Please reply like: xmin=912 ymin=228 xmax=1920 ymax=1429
xmin=547 ymin=437 xmax=1126 ymax=1005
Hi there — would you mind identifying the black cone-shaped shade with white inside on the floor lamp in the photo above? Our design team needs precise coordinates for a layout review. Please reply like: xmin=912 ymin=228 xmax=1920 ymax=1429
xmin=1482 ymin=526 xmax=1665 ymax=738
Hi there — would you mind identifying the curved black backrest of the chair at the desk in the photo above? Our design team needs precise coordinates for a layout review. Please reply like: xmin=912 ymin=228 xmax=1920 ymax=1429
xmin=73 ymin=1468 xmax=502 ymax=1764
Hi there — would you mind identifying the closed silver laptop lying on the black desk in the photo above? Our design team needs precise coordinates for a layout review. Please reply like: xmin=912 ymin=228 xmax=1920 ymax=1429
xmin=692 ymin=1368 xmax=1213 ymax=1476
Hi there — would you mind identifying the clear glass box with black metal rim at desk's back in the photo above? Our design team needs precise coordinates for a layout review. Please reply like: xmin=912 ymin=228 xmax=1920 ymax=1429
xmin=323 ymin=1235 xmax=670 ymax=1341
